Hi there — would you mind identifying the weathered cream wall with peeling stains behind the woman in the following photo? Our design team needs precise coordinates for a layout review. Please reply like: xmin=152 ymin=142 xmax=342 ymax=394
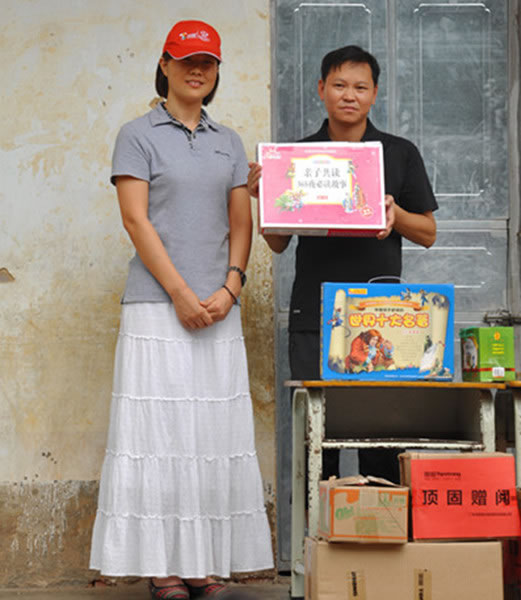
xmin=0 ymin=0 xmax=275 ymax=587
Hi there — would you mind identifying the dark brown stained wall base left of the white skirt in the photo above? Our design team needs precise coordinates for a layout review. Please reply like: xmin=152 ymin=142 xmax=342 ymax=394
xmin=0 ymin=481 xmax=98 ymax=588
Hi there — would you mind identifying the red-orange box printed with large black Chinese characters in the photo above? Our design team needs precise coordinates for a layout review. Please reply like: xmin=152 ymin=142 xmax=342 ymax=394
xmin=400 ymin=452 xmax=521 ymax=540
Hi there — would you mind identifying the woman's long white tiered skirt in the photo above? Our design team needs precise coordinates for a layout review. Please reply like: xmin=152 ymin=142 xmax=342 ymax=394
xmin=90 ymin=303 xmax=273 ymax=578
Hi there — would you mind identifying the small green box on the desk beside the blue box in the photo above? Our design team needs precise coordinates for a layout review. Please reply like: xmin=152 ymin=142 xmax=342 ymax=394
xmin=459 ymin=327 xmax=516 ymax=381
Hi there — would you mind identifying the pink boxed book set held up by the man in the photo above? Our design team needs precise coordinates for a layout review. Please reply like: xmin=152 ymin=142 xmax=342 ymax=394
xmin=257 ymin=142 xmax=385 ymax=236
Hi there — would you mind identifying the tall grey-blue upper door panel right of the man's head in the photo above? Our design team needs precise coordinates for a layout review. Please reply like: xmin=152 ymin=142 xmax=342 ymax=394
xmin=396 ymin=0 xmax=509 ymax=220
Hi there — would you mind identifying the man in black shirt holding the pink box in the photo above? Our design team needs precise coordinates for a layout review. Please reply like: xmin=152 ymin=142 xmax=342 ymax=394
xmin=248 ymin=46 xmax=438 ymax=481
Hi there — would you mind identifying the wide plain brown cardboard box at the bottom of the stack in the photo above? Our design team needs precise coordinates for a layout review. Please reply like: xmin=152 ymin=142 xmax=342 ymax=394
xmin=305 ymin=538 xmax=503 ymax=600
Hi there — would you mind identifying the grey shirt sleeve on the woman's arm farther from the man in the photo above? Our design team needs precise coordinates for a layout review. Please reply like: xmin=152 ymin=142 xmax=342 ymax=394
xmin=110 ymin=123 xmax=150 ymax=185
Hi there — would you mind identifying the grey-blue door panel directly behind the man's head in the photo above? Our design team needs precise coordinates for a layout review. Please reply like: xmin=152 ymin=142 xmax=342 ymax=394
xmin=273 ymin=0 xmax=387 ymax=141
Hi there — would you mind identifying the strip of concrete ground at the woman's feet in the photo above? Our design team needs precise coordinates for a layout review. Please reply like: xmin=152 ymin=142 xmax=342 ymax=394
xmin=0 ymin=582 xmax=289 ymax=600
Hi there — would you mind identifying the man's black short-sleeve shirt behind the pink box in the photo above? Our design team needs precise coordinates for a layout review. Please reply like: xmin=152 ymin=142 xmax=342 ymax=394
xmin=289 ymin=119 xmax=438 ymax=331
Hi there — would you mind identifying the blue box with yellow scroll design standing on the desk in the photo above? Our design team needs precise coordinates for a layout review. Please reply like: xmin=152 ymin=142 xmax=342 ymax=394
xmin=320 ymin=282 xmax=454 ymax=381
